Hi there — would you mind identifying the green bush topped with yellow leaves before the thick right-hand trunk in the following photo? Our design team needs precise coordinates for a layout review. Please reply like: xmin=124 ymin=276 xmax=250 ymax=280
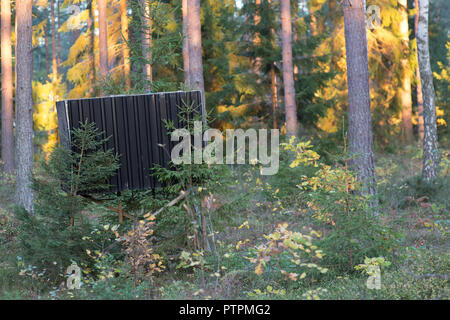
xmin=285 ymin=139 xmax=394 ymax=273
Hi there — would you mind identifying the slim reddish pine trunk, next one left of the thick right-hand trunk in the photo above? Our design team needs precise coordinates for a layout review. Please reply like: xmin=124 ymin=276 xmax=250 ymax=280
xmin=281 ymin=0 xmax=298 ymax=136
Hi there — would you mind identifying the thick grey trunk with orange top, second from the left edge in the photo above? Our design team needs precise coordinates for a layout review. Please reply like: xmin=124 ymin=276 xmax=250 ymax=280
xmin=16 ymin=0 xmax=33 ymax=212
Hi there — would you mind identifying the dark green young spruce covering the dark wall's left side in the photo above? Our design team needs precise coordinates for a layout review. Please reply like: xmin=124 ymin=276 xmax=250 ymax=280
xmin=16 ymin=122 xmax=118 ymax=280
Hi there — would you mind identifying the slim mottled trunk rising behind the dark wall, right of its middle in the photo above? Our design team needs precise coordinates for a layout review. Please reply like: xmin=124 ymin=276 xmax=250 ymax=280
xmin=141 ymin=0 xmax=153 ymax=91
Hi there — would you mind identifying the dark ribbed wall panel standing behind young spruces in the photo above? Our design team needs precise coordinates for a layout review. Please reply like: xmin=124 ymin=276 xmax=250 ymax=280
xmin=56 ymin=91 xmax=204 ymax=192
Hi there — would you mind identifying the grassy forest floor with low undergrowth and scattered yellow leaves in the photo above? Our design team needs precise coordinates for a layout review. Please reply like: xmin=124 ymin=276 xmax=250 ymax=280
xmin=0 ymin=144 xmax=450 ymax=300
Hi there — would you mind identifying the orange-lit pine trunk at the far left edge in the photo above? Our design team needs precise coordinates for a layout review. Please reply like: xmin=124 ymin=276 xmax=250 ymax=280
xmin=1 ymin=0 xmax=14 ymax=174
